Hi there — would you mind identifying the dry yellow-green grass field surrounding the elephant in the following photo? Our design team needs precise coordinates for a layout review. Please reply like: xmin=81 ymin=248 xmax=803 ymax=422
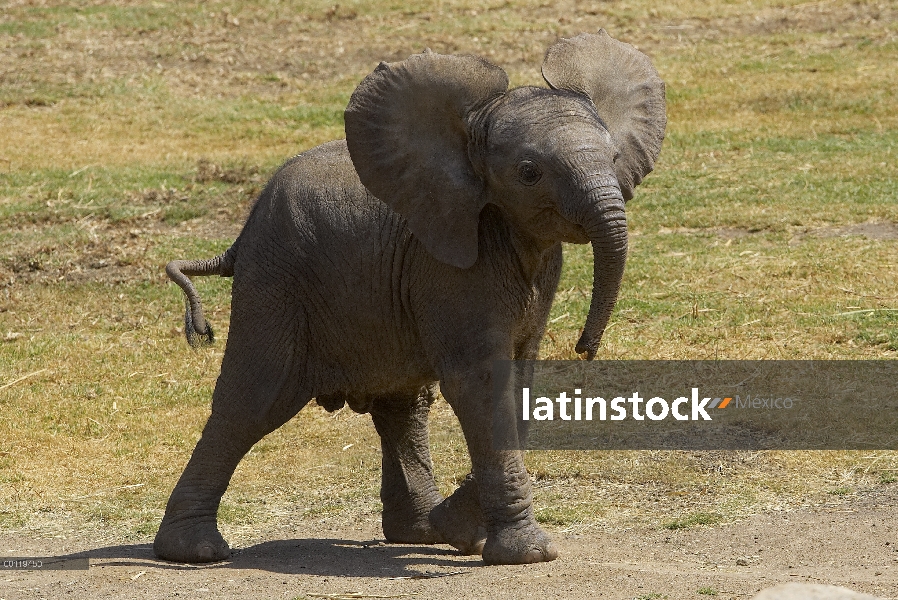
xmin=0 ymin=0 xmax=898 ymax=543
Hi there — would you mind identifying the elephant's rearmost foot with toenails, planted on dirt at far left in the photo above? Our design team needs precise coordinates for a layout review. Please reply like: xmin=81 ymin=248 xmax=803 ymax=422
xmin=153 ymin=518 xmax=231 ymax=563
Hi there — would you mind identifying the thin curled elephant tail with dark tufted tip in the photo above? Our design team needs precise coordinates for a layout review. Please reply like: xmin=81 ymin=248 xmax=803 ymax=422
xmin=165 ymin=244 xmax=237 ymax=348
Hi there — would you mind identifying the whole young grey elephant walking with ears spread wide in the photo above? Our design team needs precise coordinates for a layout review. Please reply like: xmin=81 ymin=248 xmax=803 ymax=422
xmin=153 ymin=30 xmax=667 ymax=564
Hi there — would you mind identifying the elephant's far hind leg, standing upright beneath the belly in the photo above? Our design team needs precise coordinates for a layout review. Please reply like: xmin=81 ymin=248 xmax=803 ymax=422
xmin=371 ymin=387 xmax=444 ymax=544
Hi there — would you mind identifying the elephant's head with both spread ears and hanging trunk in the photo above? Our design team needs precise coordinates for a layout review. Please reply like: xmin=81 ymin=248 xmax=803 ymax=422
xmin=345 ymin=30 xmax=667 ymax=359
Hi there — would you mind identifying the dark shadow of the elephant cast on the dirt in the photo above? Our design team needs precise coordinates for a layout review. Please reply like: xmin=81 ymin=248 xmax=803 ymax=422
xmin=65 ymin=539 xmax=483 ymax=578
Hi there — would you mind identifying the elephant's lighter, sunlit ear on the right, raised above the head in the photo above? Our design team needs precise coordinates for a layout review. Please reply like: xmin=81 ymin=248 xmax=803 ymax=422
xmin=543 ymin=29 xmax=667 ymax=200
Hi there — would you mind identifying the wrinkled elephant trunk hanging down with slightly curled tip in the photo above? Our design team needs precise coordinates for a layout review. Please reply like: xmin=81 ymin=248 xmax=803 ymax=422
xmin=576 ymin=181 xmax=627 ymax=360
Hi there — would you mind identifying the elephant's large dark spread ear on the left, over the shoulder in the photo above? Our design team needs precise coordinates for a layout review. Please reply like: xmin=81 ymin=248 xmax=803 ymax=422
xmin=345 ymin=50 xmax=508 ymax=269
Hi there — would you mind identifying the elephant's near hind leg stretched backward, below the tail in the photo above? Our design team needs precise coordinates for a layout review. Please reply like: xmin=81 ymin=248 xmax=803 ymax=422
xmin=153 ymin=282 xmax=311 ymax=563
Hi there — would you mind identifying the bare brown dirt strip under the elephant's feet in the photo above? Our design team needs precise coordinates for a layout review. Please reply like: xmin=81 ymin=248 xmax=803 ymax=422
xmin=0 ymin=485 xmax=898 ymax=600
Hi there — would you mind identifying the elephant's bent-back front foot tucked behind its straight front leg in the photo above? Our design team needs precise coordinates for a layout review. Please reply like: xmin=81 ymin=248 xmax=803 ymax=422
xmin=430 ymin=475 xmax=486 ymax=555
